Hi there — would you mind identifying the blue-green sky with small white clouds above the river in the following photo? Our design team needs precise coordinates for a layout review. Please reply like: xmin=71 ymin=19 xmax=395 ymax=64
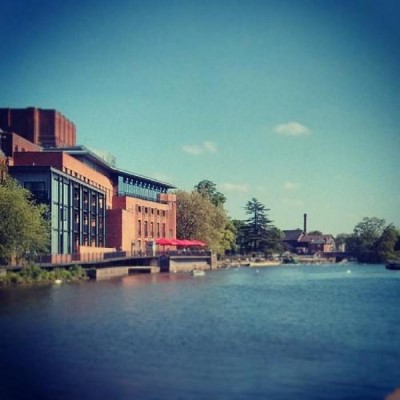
xmin=0 ymin=0 xmax=400 ymax=234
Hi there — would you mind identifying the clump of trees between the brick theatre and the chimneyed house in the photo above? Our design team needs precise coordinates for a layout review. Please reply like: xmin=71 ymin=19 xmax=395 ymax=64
xmin=176 ymin=180 xmax=282 ymax=255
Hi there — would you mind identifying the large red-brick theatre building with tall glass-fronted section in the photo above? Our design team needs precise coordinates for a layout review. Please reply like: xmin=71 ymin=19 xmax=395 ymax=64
xmin=0 ymin=109 xmax=176 ymax=254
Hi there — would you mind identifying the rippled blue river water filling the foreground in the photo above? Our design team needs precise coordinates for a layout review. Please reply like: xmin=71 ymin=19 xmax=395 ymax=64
xmin=0 ymin=264 xmax=400 ymax=400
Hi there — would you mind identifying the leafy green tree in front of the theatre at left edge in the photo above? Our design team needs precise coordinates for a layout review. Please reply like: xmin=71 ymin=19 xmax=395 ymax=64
xmin=0 ymin=176 xmax=50 ymax=263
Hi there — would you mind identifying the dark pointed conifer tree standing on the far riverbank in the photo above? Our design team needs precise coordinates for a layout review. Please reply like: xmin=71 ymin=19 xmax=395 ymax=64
xmin=240 ymin=198 xmax=272 ymax=252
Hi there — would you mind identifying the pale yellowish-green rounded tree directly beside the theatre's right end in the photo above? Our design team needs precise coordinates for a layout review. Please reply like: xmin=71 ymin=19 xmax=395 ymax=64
xmin=176 ymin=191 xmax=231 ymax=253
